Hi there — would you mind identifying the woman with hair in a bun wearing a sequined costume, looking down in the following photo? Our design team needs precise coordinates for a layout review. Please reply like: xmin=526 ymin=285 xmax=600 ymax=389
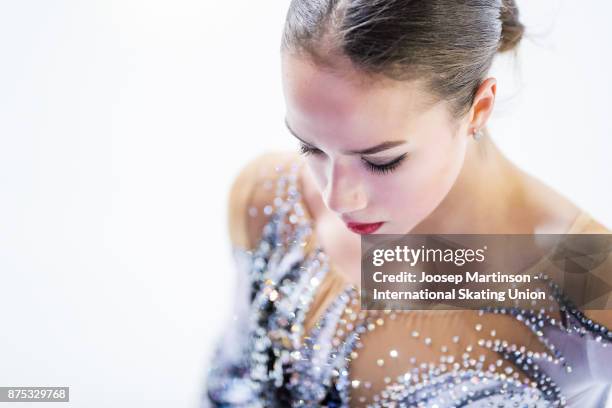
xmin=205 ymin=0 xmax=612 ymax=407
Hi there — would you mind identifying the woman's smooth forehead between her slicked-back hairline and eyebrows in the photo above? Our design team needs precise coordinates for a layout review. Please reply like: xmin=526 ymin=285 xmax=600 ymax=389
xmin=282 ymin=53 xmax=442 ymax=143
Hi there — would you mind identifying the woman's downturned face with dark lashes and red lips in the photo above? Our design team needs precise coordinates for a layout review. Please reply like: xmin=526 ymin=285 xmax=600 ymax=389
xmin=282 ymin=52 xmax=469 ymax=234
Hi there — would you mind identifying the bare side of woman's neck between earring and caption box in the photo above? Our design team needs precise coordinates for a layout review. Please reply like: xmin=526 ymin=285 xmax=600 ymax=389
xmin=410 ymin=131 xmax=530 ymax=234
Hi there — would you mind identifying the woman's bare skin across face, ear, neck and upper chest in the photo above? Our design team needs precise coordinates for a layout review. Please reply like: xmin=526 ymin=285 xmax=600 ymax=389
xmin=282 ymin=51 xmax=580 ymax=284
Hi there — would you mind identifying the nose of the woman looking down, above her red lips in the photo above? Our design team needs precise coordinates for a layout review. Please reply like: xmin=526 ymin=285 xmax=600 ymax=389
xmin=324 ymin=162 xmax=367 ymax=214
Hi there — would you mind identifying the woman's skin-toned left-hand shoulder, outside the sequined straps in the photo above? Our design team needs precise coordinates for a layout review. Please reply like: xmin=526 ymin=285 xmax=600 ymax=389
xmin=227 ymin=151 xmax=300 ymax=249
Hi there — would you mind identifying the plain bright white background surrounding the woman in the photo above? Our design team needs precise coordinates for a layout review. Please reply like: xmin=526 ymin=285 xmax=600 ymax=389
xmin=0 ymin=0 xmax=612 ymax=408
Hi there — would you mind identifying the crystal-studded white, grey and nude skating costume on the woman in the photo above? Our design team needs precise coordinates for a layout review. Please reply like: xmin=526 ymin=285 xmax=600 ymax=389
xmin=203 ymin=151 xmax=612 ymax=407
